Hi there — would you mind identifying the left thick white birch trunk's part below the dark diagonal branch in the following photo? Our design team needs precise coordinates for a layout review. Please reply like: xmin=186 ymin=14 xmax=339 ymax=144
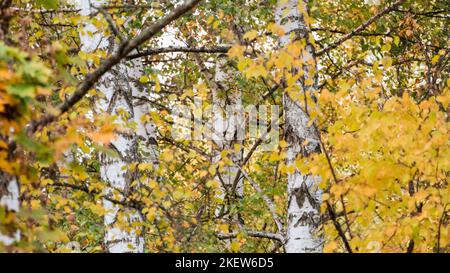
xmin=98 ymin=64 xmax=144 ymax=253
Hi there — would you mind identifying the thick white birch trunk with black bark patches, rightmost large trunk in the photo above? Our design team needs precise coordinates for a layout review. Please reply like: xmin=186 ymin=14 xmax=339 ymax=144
xmin=275 ymin=0 xmax=323 ymax=253
